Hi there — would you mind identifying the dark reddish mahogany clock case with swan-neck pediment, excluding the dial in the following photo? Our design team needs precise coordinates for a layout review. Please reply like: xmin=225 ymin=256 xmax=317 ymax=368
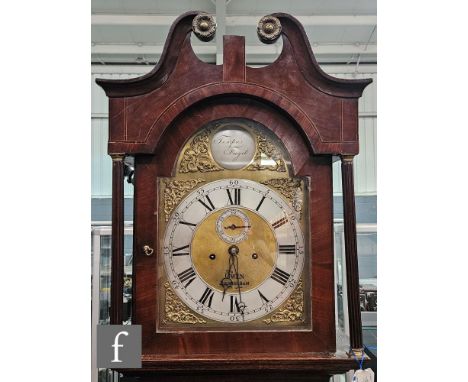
xmin=97 ymin=12 xmax=370 ymax=380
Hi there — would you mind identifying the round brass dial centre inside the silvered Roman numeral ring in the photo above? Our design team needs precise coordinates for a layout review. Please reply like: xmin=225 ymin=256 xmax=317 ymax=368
xmin=191 ymin=207 xmax=278 ymax=292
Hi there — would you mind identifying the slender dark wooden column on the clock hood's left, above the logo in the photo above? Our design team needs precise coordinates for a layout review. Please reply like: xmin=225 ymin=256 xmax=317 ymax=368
xmin=110 ymin=155 xmax=124 ymax=325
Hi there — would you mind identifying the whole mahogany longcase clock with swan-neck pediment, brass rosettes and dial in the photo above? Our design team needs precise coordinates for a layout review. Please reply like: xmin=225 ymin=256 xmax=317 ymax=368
xmin=97 ymin=12 xmax=370 ymax=381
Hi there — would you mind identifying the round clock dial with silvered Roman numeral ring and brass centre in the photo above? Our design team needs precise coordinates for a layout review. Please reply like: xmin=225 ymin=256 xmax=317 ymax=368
xmin=163 ymin=179 xmax=304 ymax=323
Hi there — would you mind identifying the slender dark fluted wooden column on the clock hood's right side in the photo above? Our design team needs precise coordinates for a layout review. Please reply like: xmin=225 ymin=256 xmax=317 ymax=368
xmin=341 ymin=155 xmax=363 ymax=351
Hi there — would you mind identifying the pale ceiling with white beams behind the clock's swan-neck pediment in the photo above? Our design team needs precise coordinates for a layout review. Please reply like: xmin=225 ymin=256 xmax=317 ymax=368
xmin=91 ymin=0 xmax=377 ymax=65
